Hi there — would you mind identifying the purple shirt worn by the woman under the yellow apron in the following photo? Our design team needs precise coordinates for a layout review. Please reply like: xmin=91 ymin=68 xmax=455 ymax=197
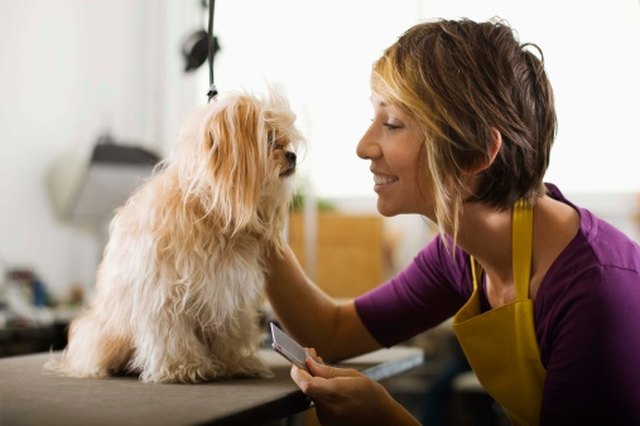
xmin=356 ymin=185 xmax=640 ymax=424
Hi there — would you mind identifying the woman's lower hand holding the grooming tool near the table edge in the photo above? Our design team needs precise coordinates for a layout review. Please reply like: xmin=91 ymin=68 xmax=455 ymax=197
xmin=291 ymin=350 xmax=419 ymax=425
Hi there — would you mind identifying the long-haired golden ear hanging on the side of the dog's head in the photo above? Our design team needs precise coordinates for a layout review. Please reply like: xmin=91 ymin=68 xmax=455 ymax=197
xmin=203 ymin=95 xmax=268 ymax=233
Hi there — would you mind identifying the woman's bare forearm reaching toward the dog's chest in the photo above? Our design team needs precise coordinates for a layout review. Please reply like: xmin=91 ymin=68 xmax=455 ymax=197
xmin=266 ymin=247 xmax=381 ymax=361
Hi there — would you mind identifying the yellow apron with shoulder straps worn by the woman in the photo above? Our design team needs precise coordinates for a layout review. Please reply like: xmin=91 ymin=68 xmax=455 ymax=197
xmin=453 ymin=200 xmax=546 ymax=425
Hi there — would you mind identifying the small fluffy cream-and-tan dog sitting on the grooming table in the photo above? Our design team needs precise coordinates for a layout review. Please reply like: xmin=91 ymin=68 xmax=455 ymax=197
xmin=47 ymin=90 xmax=300 ymax=383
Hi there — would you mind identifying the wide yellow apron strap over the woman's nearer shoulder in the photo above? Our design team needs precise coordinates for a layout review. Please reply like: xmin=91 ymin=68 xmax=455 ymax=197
xmin=511 ymin=199 xmax=533 ymax=300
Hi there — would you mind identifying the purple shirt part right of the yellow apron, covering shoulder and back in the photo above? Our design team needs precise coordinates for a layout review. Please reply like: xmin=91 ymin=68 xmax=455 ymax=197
xmin=534 ymin=190 xmax=640 ymax=417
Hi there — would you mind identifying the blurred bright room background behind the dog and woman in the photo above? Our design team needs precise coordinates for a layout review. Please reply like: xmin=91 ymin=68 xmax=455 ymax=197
xmin=0 ymin=0 xmax=640 ymax=422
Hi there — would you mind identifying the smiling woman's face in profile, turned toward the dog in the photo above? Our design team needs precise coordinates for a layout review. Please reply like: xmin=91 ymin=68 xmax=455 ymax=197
xmin=357 ymin=94 xmax=434 ymax=219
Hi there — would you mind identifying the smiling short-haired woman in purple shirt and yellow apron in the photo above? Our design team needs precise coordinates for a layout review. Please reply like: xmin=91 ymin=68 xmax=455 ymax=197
xmin=267 ymin=20 xmax=640 ymax=425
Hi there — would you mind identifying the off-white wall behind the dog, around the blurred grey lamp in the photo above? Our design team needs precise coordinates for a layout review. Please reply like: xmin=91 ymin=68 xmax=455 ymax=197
xmin=0 ymin=0 xmax=200 ymax=297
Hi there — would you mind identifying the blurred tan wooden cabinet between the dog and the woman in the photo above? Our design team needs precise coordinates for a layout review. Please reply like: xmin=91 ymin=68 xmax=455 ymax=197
xmin=289 ymin=212 xmax=385 ymax=298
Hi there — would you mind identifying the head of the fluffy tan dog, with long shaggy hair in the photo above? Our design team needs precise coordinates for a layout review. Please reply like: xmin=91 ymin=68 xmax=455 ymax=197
xmin=172 ymin=92 xmax=301 ymax=243
